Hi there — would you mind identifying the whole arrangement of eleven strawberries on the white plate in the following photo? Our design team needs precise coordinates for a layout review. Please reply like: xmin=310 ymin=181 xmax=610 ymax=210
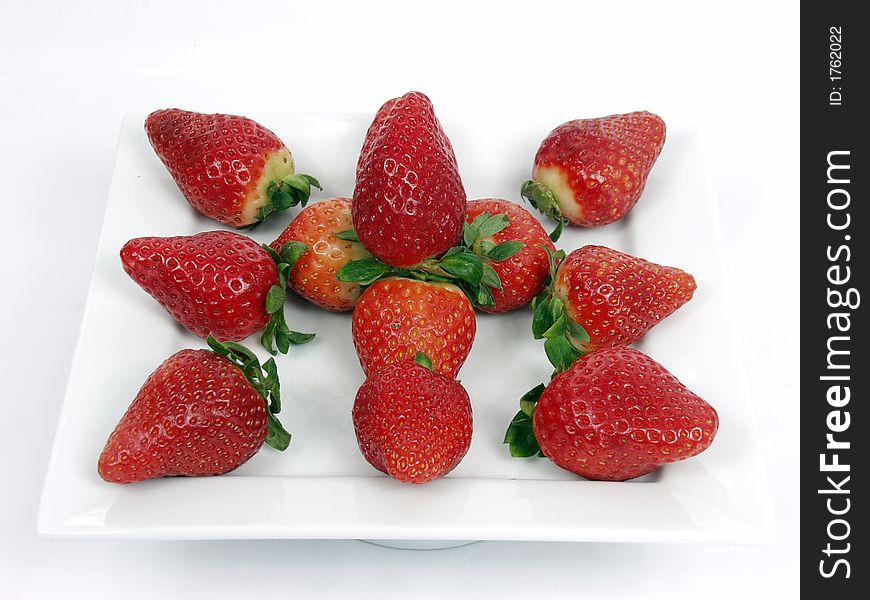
xmin=99 ymin=92 xmax=718 ymax=483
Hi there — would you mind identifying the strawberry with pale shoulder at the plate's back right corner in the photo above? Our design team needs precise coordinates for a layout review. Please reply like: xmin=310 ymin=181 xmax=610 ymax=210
xmin=522 ymin=112 xmax=665 ymax=241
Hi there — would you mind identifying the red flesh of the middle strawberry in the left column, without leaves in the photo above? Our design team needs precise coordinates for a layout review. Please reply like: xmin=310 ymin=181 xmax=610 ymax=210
xmin=121 ymin=231 xmax=278 ymax=341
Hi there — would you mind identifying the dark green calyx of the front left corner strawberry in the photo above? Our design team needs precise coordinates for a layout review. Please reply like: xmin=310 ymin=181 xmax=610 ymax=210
xmin=206 ymin=334 xmax=291 ymax=452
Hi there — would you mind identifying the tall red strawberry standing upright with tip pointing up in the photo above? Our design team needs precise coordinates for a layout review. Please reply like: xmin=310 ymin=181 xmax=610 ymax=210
xmin=353 ymin=92 xmax=466 ymax=267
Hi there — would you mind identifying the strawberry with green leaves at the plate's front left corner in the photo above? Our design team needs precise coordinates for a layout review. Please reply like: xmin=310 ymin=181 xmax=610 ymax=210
xmin=97 ymin=338 xmax=290 ymax=483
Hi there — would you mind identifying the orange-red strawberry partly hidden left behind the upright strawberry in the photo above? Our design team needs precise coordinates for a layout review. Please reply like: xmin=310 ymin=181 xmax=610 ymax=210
xmin=270 ymin=198 xmax=370 ymax=312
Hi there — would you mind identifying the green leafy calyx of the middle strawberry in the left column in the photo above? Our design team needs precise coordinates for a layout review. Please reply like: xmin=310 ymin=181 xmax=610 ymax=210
xmin=260 ymin=241 xmax=314 ymax=354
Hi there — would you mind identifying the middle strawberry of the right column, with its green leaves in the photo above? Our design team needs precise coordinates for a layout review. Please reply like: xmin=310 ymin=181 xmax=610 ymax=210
xmin=532 ymin=245 xmax=696 ymax=370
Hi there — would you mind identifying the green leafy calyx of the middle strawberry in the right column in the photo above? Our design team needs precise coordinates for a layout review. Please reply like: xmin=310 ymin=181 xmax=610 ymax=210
xmin=532 ymin=247 xmax=590 ymax=375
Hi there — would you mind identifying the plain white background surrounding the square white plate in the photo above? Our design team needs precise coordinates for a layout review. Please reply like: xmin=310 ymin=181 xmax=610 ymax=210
xmin=0 ymin=0 xmax=800 ymax=598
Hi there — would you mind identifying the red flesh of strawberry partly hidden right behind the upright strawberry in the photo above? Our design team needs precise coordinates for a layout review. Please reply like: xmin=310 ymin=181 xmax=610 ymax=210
xmin=465 ymin=198 xmax=556 ymax=313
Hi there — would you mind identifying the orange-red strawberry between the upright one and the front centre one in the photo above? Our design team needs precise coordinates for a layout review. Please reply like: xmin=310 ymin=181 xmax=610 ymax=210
xmin=351 ymin=278 xmax=477 ymax=378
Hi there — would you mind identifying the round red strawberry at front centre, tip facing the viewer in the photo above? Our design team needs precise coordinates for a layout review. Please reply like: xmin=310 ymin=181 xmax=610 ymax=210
xmin=353 ymin=361 xmax=473 ymax=483
